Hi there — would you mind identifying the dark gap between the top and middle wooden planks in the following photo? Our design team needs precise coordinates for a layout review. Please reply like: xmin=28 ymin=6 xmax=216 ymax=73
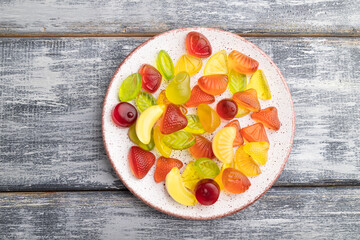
xmin=0 ymin=32 xmax=360 ymax=38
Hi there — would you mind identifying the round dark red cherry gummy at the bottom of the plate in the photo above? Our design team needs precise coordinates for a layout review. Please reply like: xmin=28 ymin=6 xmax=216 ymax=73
xmin=195 ymin=179 xmax=220 ymax=205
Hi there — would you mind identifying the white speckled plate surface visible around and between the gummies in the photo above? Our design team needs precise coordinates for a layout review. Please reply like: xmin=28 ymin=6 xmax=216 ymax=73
xmin=102 ymin=28 xmax=295 ymax=219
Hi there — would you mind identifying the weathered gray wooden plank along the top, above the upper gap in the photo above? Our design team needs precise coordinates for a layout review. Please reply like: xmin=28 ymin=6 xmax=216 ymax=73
xmin=0 ymin=0 xmax=360 ymax=36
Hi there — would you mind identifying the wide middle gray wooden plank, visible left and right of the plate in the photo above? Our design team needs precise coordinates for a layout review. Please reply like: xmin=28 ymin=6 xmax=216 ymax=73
xmin=0 ymin=38 xmax=360 ymax=191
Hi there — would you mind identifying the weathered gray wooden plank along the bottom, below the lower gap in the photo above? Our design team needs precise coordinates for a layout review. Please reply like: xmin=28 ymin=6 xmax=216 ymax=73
xmin=0 ymin=187 xmax=360 ymax=239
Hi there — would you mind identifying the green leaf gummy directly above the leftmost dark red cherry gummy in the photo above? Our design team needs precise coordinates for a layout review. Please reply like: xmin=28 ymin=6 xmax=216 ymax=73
xmin=119 ymin=73 xmax=142 ymax=102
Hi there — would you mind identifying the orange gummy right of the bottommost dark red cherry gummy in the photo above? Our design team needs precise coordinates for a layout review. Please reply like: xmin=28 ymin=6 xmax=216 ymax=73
xmin=222 ymin=168 xmax=251 ymax=194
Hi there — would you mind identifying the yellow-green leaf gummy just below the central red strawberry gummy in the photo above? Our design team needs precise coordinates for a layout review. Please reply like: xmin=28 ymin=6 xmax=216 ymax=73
xmin=163 ymin=130 xmax=196 ymax=150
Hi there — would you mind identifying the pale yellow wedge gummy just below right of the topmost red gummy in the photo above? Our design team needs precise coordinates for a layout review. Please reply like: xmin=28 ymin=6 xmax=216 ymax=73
xmin=204 ymin=50 xmax=229 ymax=75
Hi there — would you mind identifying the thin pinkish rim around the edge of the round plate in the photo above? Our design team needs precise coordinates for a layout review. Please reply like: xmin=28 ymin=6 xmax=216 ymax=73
xmin=101 ymin=27 xmax=295 ymax=220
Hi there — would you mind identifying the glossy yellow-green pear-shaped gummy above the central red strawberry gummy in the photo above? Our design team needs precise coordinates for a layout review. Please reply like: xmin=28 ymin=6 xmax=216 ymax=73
xmin=165 ymin=72 xmax=191 ymax=105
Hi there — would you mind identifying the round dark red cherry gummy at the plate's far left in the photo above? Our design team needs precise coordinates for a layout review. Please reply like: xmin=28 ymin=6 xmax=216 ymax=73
xmin=111 ymin=102 xmax=137 ymax=128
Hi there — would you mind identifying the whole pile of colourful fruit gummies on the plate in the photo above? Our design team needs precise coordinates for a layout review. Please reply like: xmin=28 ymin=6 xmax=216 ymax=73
xmin=112 ymin=32 xmax=280 ymax=205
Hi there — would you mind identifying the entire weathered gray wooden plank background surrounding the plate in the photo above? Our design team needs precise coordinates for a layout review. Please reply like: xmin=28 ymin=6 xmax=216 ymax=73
xmin=0 ymin=0 xmax=360 ymax=239
